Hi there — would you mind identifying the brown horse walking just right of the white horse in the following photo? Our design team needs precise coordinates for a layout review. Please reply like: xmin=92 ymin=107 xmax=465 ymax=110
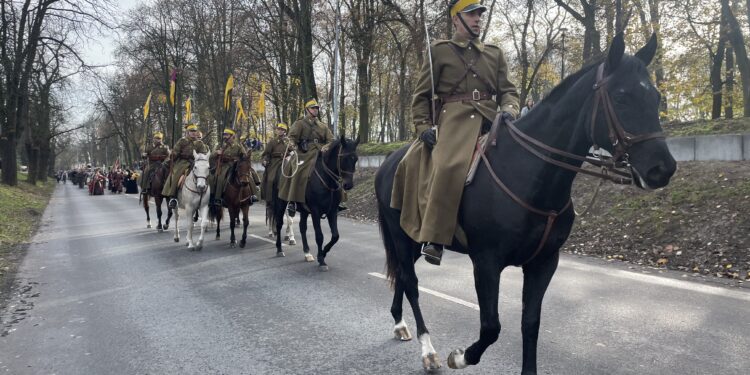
xmin=208 ymin=157 xmax=253 ymax=248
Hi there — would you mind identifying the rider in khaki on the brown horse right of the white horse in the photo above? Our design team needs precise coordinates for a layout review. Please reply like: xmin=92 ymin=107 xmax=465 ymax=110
xmin=208 ymin=128 xmax=258 ymax=207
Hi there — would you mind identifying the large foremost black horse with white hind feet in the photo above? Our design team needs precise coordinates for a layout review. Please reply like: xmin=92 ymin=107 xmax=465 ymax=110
xmin=375 ymin=34 xmax=676 ymax=374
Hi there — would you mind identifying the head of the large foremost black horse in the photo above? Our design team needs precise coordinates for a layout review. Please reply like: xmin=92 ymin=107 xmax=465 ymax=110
xmin=586 ymin=33 xmax=676 ymax=189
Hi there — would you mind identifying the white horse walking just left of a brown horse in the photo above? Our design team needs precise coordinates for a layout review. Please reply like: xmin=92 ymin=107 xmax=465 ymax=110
xmin=174 ymin=151 xmax=211 ymax=251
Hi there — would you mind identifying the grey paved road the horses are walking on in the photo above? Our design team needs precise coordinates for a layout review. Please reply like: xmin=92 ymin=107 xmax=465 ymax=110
xmin=0 ymin=185 xmax=750 ymax=375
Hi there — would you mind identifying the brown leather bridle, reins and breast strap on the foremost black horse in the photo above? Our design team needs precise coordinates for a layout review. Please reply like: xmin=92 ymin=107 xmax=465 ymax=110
xmin=480 ymin=63 xmax=665 ymax=265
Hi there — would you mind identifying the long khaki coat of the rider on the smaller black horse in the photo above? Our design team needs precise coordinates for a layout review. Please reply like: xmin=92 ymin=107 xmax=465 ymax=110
xmin=279 ymin=116 xmax=333 ymax=203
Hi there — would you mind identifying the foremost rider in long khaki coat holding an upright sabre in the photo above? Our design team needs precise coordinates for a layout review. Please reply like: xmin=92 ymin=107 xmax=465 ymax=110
xmin=391 ymin=0 xmax=519 ymax=265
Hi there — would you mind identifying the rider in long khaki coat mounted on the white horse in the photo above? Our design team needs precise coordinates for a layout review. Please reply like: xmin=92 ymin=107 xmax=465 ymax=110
xmin=161 ymin=124 xmax=208 ymax=209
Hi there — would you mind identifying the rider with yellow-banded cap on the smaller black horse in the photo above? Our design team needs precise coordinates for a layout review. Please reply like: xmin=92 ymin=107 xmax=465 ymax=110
xmin=279 ymin=98 xmax=346 ymax=213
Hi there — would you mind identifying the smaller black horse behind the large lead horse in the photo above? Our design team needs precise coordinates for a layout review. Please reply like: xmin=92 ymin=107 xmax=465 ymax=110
xmin=271 ymin=136 xmax=359 ymax=271
